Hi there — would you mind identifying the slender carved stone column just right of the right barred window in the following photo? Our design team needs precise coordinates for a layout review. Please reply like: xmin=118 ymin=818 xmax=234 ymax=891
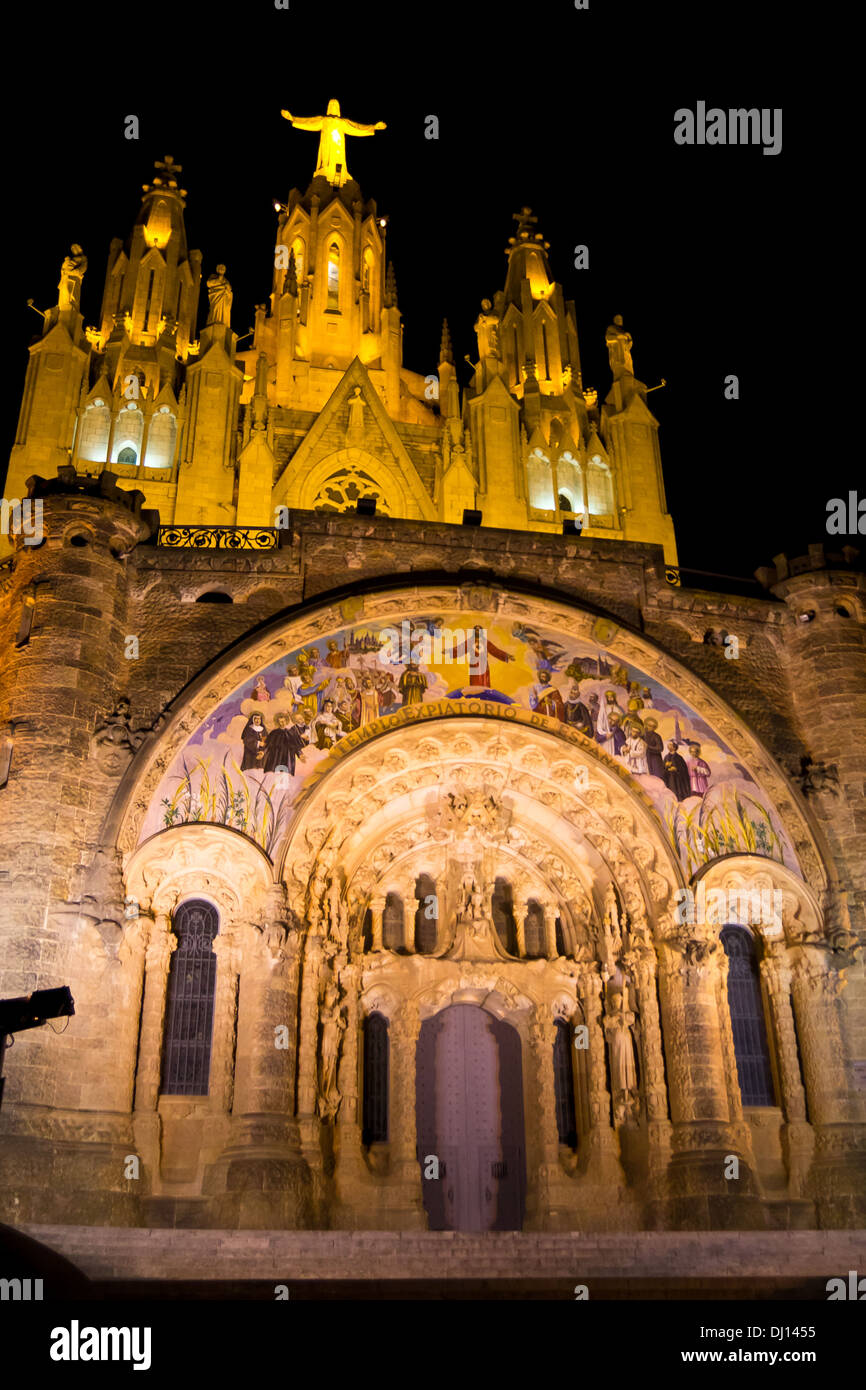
xmin=760 ymin=942 xmax=815 ymax=1198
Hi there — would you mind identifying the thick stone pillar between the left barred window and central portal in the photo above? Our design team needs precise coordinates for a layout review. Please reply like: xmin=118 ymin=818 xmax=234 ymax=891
xmin=207 ymin=890 xmax=311 ymax=1230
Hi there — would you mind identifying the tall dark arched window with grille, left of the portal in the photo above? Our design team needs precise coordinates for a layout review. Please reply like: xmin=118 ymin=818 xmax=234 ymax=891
xmin=161 ymin=901 xmax=220 ymax=1095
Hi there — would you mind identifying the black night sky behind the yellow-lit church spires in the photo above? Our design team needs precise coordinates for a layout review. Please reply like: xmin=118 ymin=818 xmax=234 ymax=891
xmin=3 ymin=0 xmax=834 ymax=588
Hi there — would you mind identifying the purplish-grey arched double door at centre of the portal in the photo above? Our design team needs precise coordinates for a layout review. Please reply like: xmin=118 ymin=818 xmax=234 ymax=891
xmin=416 ymin=1004 xmax=525 ymax=1230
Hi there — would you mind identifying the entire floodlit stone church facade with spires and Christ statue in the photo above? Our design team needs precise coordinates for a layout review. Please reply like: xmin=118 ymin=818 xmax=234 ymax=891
xmin=0 ymin=101 xmax=866 ymax=1251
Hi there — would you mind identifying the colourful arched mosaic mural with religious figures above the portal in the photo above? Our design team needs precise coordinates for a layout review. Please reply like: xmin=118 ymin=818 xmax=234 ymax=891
xmin=142 ymin=610 xmax=799 ymax=874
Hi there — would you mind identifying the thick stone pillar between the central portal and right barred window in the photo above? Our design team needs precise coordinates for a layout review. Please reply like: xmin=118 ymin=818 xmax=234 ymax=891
xmin=660 ymin=934 xmax=766 ymax=1230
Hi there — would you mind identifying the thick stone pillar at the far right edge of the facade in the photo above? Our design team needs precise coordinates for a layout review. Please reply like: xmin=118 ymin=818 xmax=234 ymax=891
xmin=792 ymin=945 xmax=866 ymax=1229
